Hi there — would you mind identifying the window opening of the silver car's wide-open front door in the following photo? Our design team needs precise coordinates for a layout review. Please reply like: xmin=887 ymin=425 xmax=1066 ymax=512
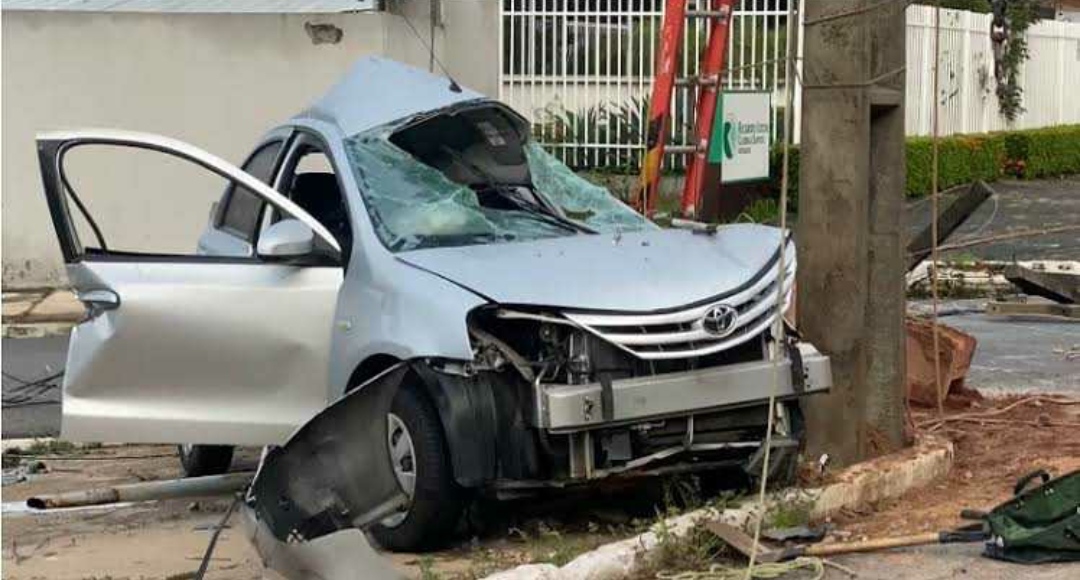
xmin=48 ymin=133 xmax=337 ymax=259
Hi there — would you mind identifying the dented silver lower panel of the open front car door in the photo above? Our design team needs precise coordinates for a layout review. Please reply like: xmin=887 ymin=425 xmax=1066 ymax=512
xmin=62 ymin=260 xmax=341 ymax=445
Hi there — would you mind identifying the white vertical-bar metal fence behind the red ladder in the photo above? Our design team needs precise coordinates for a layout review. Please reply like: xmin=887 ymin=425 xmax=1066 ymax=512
xmin=499 ymin=0 xmax=798 ymax=170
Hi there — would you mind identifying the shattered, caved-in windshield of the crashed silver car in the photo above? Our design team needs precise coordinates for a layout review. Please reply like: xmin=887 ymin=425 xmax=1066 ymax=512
xmin=345 ymin=108 xmax=656 ymax=252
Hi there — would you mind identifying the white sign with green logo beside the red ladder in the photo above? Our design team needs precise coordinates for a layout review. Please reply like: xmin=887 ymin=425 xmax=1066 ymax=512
xmin=708 ymin=92 xmax=772 ymax=184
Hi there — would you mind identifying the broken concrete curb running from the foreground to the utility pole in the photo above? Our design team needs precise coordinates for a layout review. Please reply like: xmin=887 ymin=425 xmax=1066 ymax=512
xmin=487 ymin=436 xmax=953 ymax=580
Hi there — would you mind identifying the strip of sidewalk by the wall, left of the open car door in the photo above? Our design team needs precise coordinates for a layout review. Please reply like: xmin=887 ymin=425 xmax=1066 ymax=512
xmin=3 ymin=288 xmax=85 ymax=338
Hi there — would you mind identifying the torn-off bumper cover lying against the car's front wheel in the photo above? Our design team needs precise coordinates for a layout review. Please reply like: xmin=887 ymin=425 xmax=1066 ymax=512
xmin=241 ymin=363 xmax=410 ymax=580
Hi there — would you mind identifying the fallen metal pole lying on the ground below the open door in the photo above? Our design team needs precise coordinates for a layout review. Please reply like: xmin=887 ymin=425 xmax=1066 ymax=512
xmin=26 ymin=471 xmax=255 ymax=510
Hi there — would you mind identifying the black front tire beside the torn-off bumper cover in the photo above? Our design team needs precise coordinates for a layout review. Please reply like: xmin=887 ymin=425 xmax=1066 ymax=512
xmin=372 ymin=385 xmax=465 ymax=552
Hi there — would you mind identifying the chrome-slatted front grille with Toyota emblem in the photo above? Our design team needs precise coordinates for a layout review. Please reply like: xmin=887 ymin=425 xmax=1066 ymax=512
xmin=563 ymin=259 xmax=795 ymax=361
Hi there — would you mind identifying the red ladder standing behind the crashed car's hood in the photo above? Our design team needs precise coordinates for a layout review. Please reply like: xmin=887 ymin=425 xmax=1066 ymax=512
xmin=633 ymin=0 xmax=734 ymax=218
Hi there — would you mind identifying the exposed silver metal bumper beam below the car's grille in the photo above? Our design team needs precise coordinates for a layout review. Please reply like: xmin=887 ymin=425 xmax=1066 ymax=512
xmin=537 ymin=342 xmax=833 ymax=433
